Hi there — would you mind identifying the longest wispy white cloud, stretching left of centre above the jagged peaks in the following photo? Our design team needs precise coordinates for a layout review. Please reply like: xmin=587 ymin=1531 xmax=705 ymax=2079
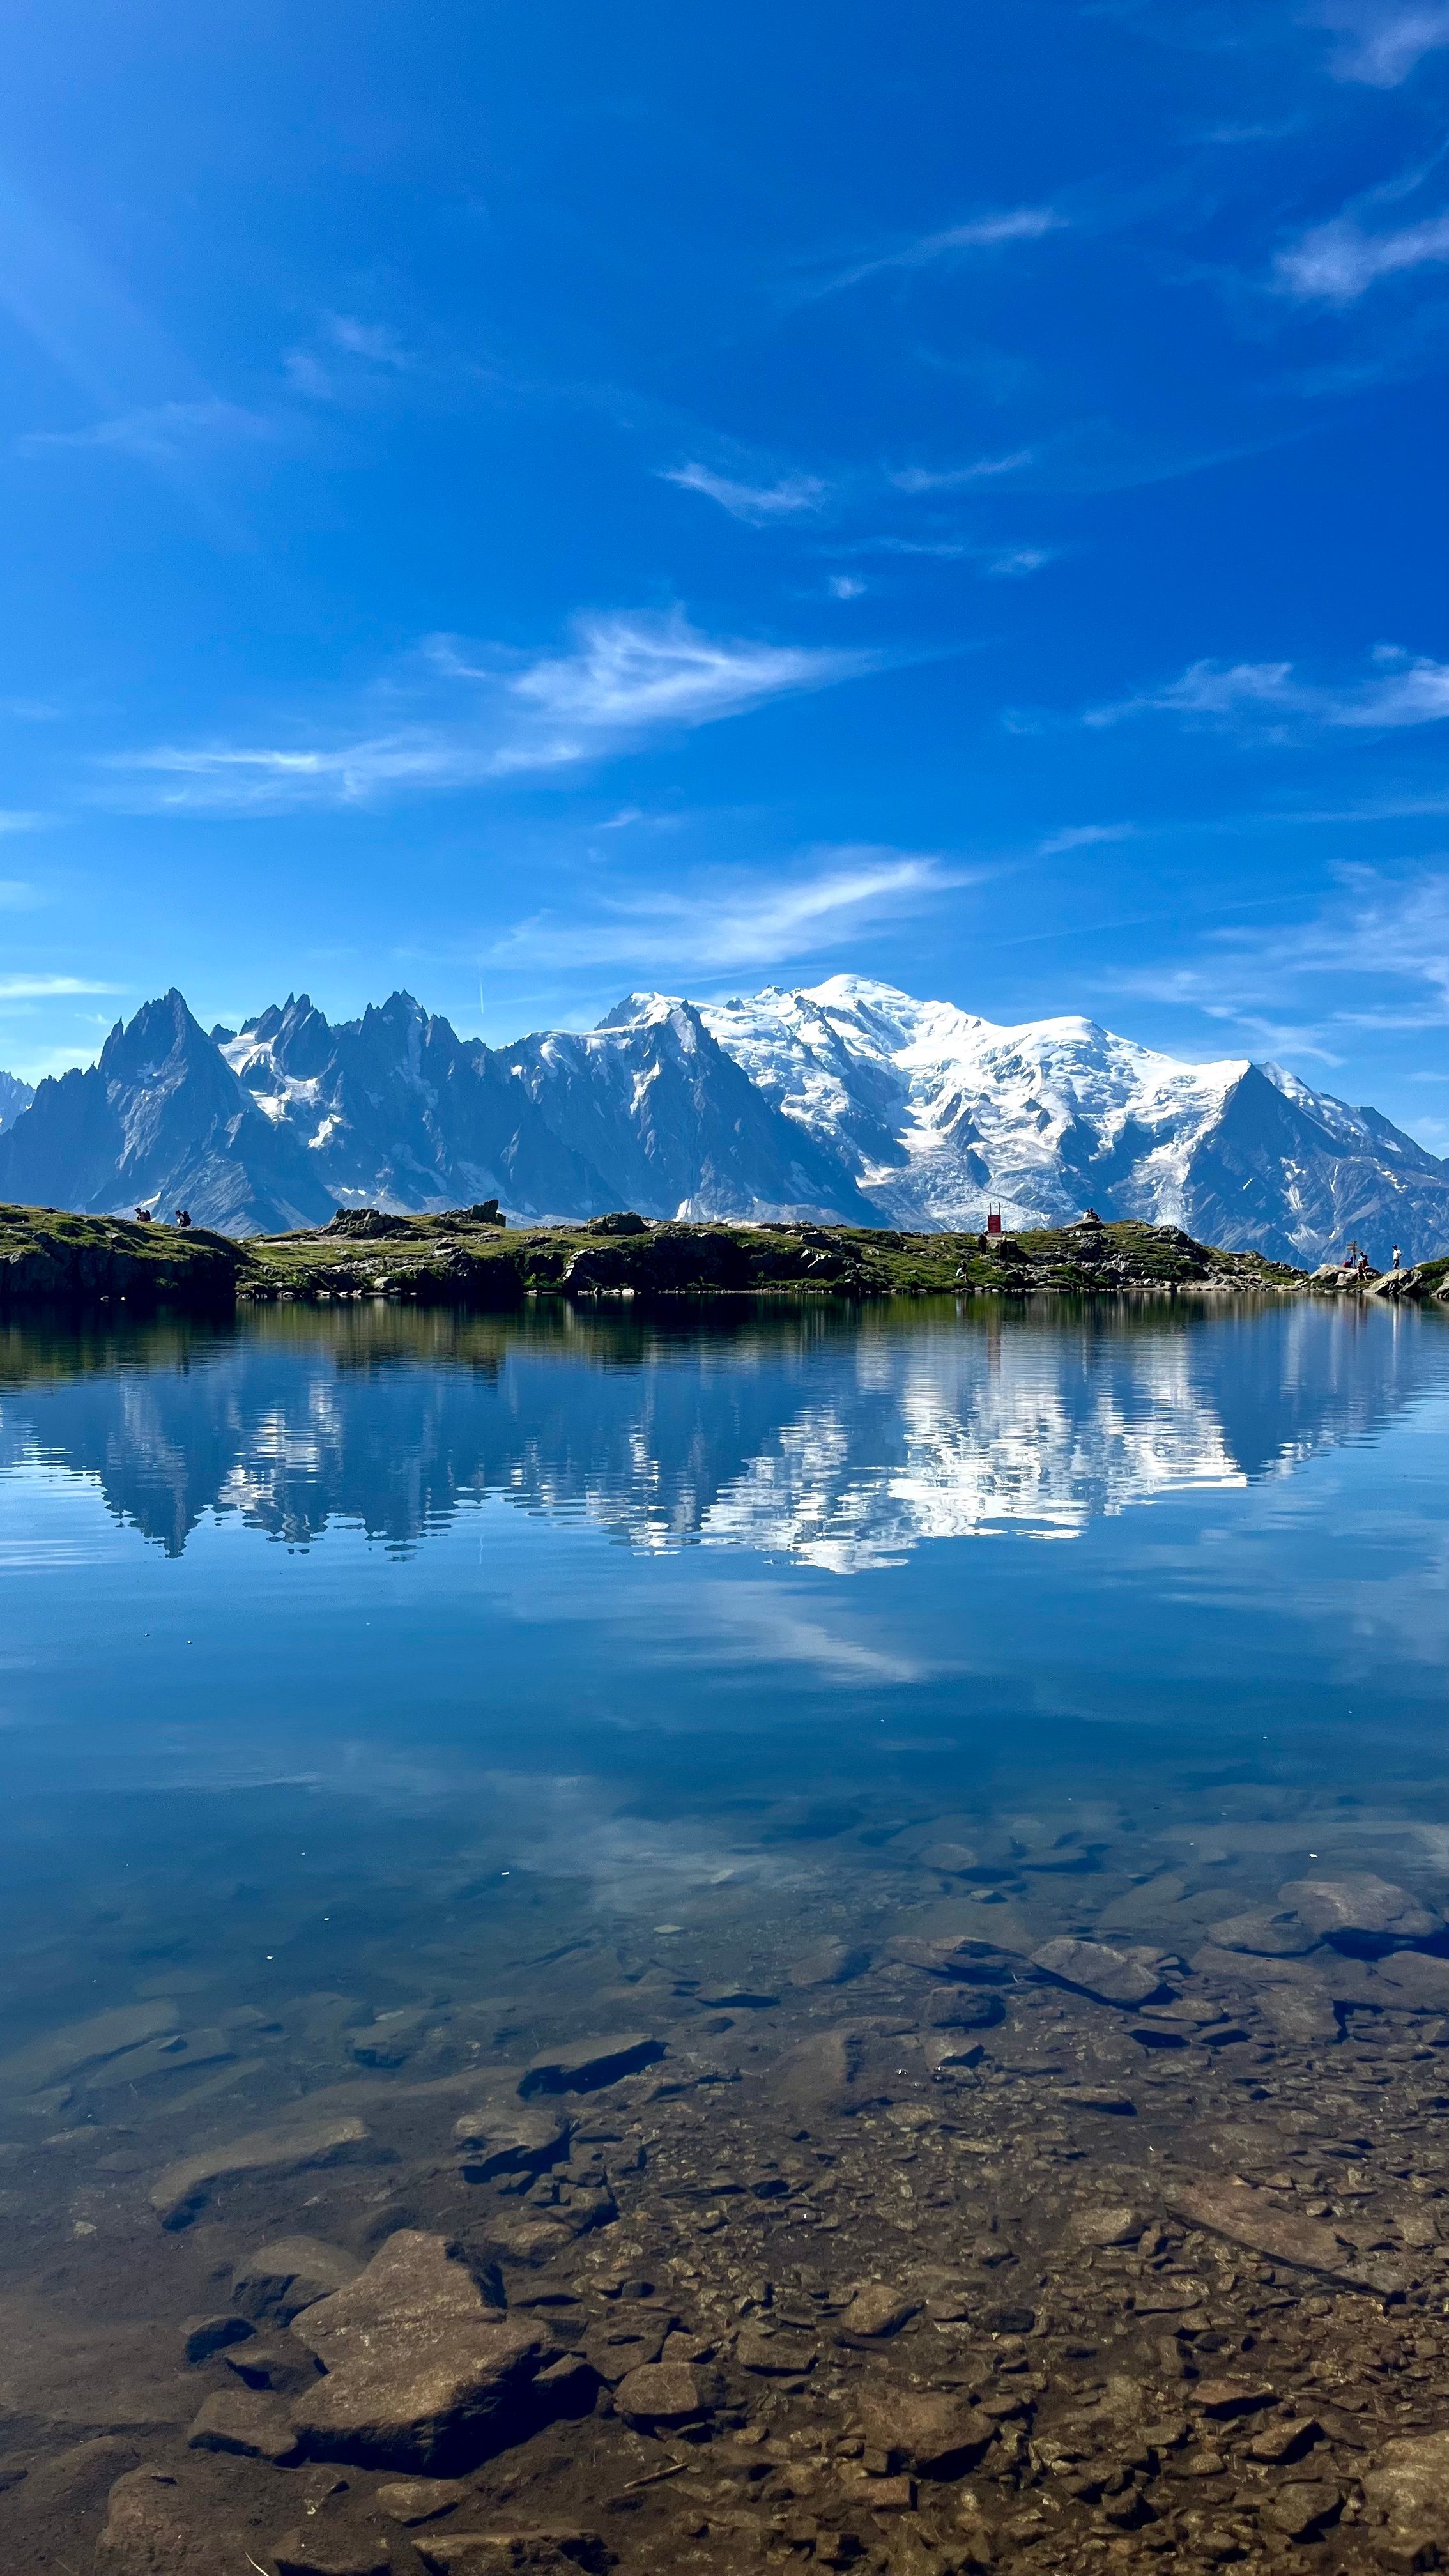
xmin=111 ymin=611 xmax=882 ymax=814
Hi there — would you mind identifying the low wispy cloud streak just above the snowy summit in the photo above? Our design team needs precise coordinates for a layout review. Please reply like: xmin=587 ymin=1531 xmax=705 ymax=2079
xmin=493 ymin=842 xmax=972 ymax=974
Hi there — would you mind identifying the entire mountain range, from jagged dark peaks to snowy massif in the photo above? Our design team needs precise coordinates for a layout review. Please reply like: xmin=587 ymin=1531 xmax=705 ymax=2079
xmin=0 ymin=976 xmax=1449 ymax=1265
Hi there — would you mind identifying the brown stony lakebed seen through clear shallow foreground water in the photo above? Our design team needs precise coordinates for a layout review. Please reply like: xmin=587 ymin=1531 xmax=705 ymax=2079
xmin=0 ymin=1819 xmax=1449 ymax=2576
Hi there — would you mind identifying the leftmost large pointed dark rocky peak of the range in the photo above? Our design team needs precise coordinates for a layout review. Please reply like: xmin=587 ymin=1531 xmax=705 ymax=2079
xmin=0 ymin=992 xmax=333 ymax=1234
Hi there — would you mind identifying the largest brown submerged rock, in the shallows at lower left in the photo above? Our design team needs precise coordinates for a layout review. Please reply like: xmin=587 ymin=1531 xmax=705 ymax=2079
xmin=291 ymin=2228 xmax=552 ymax=2471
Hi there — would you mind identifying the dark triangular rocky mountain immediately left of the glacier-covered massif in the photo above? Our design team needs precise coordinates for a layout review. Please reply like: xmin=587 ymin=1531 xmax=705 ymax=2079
xmin=505 ymin=994 xmax=879 ymax=1226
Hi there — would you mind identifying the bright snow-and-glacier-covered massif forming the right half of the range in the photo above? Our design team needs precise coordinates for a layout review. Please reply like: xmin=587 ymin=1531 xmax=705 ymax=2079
xmin=686 ymin=976 xmax=1449 ymax=1262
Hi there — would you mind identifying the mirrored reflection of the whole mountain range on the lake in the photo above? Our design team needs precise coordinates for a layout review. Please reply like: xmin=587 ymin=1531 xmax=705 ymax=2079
xmin=0 ymin=1303 xmax=1436 ymax=1574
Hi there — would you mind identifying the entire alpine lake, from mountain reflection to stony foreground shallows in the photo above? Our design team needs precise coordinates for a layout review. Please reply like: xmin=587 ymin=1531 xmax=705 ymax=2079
xmin=0 ymin=1296 xmax=1449 ymax=2576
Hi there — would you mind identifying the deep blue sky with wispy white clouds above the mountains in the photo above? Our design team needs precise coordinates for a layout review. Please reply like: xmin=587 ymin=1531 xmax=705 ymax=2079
xmin=0 ymin=0 xmax=1449 ymax=1151
